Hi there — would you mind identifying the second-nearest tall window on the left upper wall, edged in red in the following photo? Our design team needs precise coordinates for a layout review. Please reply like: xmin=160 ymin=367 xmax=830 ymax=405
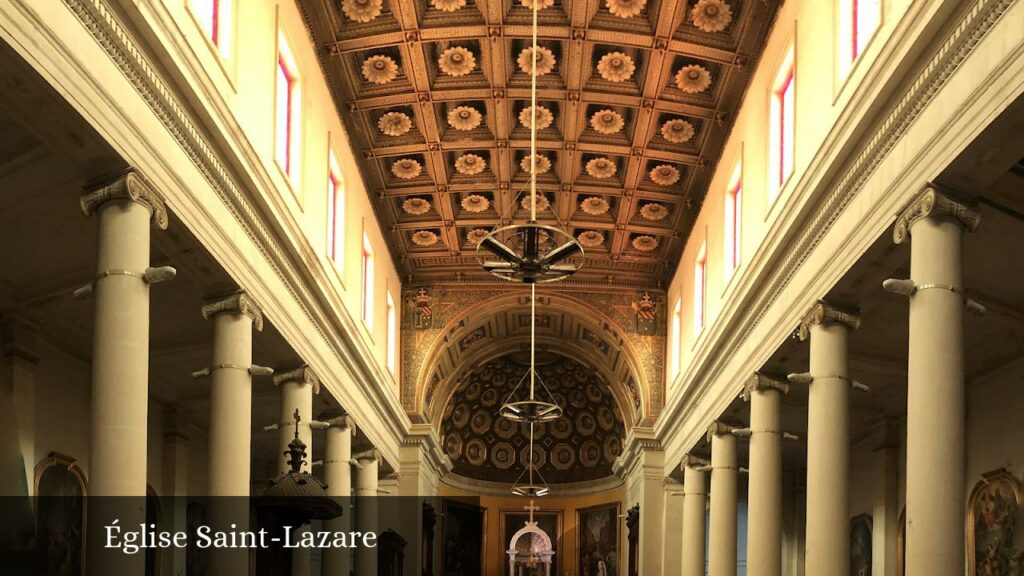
xmin=274 ymin=34 xmax=301 ymax=183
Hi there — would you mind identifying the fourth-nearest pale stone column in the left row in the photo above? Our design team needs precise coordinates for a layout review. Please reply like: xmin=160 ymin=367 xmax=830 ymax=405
xmin=323 ymin=415 xmax=355 ymax=576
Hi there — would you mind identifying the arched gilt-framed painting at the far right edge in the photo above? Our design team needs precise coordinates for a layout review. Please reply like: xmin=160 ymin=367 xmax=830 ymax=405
xmin=967 ymin=469 xmax=1024 ymax=576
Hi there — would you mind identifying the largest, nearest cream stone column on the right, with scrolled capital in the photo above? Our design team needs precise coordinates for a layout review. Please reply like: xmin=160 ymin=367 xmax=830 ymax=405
xmin=887 ymin=184 xmax=981 ymax=576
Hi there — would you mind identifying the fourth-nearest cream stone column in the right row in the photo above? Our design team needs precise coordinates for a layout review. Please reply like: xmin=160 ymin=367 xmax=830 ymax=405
xmin=708 ymin=421 xmax=738 ymax=576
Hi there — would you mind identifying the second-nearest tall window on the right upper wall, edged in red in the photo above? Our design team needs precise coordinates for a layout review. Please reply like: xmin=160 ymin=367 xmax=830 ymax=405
xmin=768 ymin=47 xmax=797 ymax=200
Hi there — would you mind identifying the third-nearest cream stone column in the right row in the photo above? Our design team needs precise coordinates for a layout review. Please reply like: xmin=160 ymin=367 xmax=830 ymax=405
xmin=743 ymin=373 xmax=790 ymax=576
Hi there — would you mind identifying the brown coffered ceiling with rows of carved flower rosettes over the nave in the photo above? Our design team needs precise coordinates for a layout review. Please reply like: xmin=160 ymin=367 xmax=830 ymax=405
xmin=300 ymin=0 xmax=779 ymax=287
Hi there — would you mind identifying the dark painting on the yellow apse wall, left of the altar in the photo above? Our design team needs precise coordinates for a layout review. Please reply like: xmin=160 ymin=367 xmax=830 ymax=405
xmin=441 ymin=500 xmax=485 ymax=576
